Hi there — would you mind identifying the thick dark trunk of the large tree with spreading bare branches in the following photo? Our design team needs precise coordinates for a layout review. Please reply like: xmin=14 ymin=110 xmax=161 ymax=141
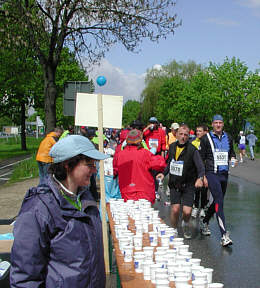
xmin=43 ymin=64 xmax=57 ymax=133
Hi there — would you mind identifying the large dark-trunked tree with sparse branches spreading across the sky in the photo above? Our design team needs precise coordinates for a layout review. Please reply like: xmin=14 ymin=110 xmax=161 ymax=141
xmin=0 ymin=0 xmax=179 ymax=131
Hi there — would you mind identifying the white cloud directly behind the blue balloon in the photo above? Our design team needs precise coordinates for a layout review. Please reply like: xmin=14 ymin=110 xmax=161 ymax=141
xmin=88 ymin=59 xmax=145 ymax=103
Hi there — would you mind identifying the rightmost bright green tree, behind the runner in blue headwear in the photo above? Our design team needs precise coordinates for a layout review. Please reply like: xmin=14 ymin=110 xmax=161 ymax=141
xmin=209 ymin=57 xmax=260 ymax=138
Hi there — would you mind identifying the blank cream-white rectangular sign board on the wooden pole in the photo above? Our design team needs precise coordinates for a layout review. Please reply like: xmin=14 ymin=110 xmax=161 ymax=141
xmin=75 ymin=93 xmax=123 ymax=129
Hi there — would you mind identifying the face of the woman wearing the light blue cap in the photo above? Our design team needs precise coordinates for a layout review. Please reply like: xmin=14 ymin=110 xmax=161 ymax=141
xmin=68 ymin=160 xmax=97 ymax=187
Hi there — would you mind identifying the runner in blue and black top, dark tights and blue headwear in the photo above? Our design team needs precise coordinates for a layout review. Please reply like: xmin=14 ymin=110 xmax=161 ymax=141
xmin=200 ymin=115 xmax=236 ymax=247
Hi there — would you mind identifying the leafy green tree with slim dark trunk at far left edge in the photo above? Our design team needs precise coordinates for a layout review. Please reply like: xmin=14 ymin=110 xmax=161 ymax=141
xmin=0 ymin=47 xmax=38 ymax=150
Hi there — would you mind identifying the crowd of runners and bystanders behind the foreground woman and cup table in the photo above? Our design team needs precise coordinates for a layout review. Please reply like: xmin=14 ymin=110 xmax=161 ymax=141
xmin=34 ymin=115 xmax=257 ymax=250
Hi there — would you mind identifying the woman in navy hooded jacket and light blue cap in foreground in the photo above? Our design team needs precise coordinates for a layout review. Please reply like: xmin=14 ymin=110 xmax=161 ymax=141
xmin=10 ymin=135 xmax=107 ymax=288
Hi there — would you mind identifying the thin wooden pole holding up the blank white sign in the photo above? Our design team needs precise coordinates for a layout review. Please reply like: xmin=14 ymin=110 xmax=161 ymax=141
xmin=97 ymin=94 xmax=110 ymax=274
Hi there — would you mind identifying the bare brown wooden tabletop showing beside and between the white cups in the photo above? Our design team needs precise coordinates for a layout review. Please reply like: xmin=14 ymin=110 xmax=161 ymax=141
xmin=107 ymin=204 xmax=175 ymax=288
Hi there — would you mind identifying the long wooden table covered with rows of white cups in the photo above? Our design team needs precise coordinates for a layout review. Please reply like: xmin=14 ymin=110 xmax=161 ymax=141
xmin=107 ymin=199 xmax=224 ymax=288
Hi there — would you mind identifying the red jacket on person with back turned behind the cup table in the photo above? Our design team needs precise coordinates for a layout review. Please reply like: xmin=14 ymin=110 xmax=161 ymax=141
xmin=113 ymin=145 xmax=166 ymax=203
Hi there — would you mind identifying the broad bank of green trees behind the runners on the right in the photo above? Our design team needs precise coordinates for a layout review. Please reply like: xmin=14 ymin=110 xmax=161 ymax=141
xmin=142 ymin=58 xmax=260 ymax=137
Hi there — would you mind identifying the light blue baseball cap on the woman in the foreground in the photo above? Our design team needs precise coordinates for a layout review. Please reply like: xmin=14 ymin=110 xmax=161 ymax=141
xmin=49 ymin=135 xmax=110 ymax=163
